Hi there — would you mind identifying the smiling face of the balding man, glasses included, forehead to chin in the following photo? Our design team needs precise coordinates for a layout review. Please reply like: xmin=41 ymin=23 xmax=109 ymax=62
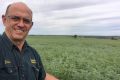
xmin=2 ymin=5 xmax=33 ymax=41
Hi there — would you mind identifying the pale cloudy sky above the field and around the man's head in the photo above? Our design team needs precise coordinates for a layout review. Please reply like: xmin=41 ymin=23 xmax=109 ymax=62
xmin=0 ymin=0 xmax=120 ymax=36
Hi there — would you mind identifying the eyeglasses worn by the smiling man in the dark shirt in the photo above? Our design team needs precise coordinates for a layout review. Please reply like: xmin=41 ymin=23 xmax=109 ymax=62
xmin=7 ymin=16 xmax=33 ymax=25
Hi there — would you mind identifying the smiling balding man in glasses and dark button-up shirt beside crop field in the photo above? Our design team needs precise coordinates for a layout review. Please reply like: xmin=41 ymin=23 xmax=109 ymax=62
xmin=0 ymin=2 xmax=57 ymax=80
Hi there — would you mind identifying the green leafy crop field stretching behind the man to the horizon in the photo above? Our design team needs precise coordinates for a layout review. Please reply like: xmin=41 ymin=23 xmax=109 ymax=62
xmin=27 ymin=36 xmax=120 ymax=80
